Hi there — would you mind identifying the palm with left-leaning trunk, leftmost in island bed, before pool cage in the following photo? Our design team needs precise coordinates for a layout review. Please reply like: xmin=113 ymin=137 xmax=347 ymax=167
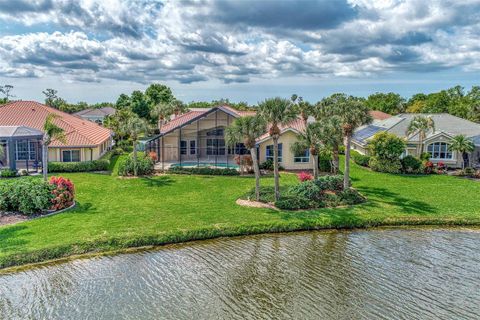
xmin=225 ymin=116 xmax=266 ymax=201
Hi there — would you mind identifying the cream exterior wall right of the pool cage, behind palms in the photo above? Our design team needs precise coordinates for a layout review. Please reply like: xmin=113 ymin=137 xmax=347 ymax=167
xmin=258 ymin=131 xmax=313 ymax=170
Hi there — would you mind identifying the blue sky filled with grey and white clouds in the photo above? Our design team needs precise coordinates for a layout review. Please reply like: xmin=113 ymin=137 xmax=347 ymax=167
xmin=0 ymin=0 xmax=480 ymax=103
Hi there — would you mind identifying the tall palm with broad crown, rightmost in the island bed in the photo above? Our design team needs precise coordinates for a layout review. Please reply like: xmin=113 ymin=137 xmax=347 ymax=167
xmin=318 ymin=93 xmax=373 ymax=189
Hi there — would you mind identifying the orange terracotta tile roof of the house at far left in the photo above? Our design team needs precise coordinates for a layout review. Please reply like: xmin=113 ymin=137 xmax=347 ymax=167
xmin=0 ymin=101 xmax=112 ymax=147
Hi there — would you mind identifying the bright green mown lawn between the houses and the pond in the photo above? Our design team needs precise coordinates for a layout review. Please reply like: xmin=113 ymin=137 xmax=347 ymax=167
xmin=0 ymin=161 xmax=480 ymax=268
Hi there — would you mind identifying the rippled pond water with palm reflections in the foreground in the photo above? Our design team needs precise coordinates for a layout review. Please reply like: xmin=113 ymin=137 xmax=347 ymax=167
xmin=0 ymin=229 xmax=480 ymax=319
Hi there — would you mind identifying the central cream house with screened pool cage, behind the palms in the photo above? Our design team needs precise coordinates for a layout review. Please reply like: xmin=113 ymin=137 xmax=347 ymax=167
xmin=143 ymin=106 xmax=388 ymax=170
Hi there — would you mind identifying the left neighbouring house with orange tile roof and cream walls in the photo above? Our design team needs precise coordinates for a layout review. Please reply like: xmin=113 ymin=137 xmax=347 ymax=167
xmin=0 ymin=101 xmax=112 ymax=166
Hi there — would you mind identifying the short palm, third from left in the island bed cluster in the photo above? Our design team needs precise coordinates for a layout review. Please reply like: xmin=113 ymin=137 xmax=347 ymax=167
xmin=291 ymin=123 xmax=322 ymax=179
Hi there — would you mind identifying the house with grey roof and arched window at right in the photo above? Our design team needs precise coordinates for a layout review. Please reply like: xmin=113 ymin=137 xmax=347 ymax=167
xmin=352 ymin=113 xmax=480 ymax=168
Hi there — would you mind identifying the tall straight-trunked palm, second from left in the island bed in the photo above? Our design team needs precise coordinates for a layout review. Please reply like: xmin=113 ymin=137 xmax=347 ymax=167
xmin=258 ymin=97 xmax=297 ymax=201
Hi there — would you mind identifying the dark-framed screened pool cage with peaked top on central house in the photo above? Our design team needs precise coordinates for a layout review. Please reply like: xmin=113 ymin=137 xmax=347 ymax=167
xmin=144 ymin=108 xmax=250 ymax=170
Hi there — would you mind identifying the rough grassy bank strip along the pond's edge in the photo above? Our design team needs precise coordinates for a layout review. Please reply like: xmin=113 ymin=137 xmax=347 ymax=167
xmin=0 ymin=219 xmax=480 ymax=276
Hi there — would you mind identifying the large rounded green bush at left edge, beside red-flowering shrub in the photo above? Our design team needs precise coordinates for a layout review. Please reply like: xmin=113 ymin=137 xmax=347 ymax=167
xmin=0 ymin=178 xmax=54 ymax=214
